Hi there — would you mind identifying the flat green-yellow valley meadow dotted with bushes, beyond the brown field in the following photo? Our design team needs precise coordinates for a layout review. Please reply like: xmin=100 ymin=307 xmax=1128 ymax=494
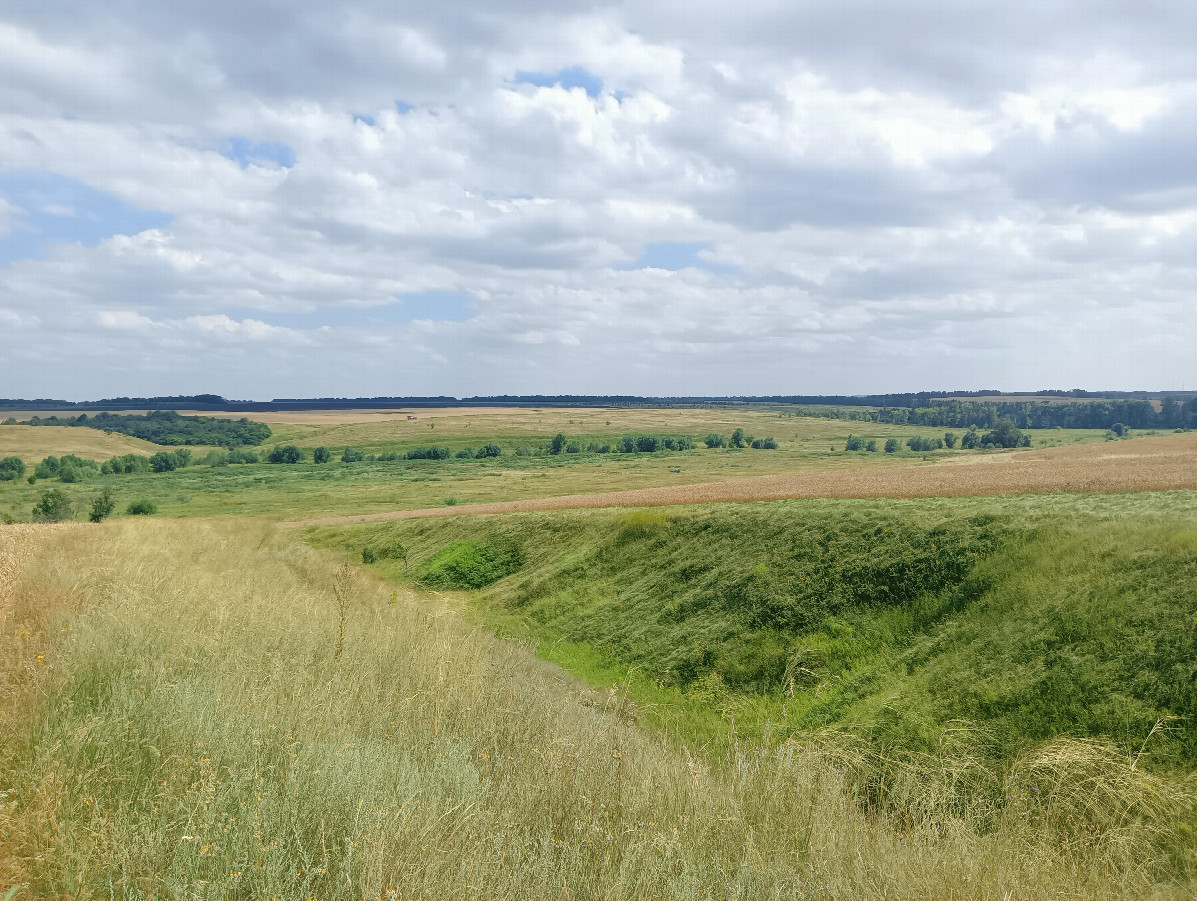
xmin=0 ymin=408 xmax=1139 ymax=520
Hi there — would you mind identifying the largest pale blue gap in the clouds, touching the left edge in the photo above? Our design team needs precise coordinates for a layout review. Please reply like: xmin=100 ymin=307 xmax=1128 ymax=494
xmin=0 ymin=171 xmax=172 ymax=266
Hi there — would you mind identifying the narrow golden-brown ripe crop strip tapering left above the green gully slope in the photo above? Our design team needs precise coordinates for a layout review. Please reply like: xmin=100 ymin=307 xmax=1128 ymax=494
xmin=284 ymin=433 xmax=1197 ymax=526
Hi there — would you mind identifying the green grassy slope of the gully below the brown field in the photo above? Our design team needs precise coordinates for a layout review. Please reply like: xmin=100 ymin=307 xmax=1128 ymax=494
xmin=311 ymin=492 xmax=1197 ymax=767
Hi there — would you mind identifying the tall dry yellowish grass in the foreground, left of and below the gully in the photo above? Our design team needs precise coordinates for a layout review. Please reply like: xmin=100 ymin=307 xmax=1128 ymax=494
xmin=0 ymin=522 xmax=1195 ymax=899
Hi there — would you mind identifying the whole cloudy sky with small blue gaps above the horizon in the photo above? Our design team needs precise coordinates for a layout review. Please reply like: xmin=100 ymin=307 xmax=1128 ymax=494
xmin=0 ymin=0 xmax=1197 ymax=400
